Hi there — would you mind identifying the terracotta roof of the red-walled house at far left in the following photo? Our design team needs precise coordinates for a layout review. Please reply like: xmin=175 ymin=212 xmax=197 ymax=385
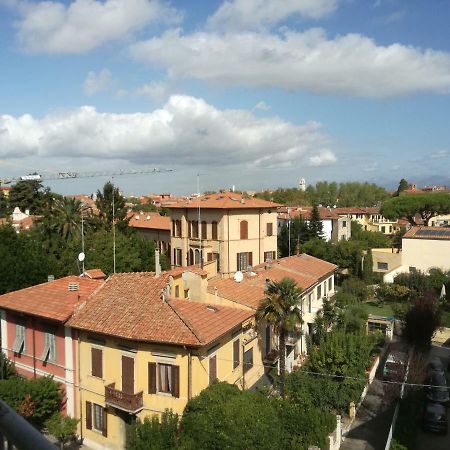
xmin=0 ymin=275 xmax=103 ymax=322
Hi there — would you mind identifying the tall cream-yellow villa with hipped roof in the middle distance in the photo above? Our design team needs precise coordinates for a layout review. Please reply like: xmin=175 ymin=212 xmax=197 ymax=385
xmin=170 ymin=192 xmax=279 ymax=275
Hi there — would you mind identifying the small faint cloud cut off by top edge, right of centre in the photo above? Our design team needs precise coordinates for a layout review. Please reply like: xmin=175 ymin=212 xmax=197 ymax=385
xmin=207 ymin=0 xmax=337 ymax=30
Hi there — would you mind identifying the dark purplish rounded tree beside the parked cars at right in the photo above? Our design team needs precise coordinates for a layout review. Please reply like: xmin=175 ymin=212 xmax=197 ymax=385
xmin=403 ymin=292 xmax=441 ymax=349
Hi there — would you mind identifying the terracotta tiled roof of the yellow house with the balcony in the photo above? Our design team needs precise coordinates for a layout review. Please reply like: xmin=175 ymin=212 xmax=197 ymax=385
xmin=68 ymin=272 xmax=255 ymax=346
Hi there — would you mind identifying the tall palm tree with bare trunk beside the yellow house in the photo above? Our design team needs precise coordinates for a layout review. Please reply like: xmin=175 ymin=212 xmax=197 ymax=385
xmin=256 ymin=277 xmax=302 ymax=398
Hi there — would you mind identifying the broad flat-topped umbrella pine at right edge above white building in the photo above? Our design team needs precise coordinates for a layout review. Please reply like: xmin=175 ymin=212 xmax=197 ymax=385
xmin=380 ymin=192 xmax=450 ymax=226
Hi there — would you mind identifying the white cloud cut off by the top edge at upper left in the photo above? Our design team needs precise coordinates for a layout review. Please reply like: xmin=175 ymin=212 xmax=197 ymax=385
xmin=16 ymin=0 xmax=180 ymax=53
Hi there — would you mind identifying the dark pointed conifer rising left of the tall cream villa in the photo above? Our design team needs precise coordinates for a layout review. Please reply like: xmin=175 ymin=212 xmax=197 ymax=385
xmin=95 ymin=181 xmax=128 ymax=232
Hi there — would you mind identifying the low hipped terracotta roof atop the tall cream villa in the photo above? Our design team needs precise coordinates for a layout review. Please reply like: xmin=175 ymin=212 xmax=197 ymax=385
xmin=169 ymin=192 xmax=281 ymax=209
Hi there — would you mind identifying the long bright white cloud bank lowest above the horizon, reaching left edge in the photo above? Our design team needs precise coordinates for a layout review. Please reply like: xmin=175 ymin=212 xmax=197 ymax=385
xmin=0 ymin=95 xmax=336 ymax=168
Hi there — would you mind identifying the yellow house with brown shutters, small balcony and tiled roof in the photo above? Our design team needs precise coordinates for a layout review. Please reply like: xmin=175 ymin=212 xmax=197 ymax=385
xmin=68 ymin=269 xmax=263 ymax=450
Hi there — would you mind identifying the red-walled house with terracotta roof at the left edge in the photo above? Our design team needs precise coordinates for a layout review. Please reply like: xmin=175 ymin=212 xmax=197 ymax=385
xmin=0 ymin=276 xmax=103 ymax=417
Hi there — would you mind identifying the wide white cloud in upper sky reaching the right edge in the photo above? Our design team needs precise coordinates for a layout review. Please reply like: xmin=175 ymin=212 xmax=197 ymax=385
xmin=130 ymin=29 xmax=450 ymax=98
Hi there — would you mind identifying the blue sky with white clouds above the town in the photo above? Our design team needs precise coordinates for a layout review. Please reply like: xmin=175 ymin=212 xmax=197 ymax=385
xmin=0 ymin=0 xmax=450 ymax=195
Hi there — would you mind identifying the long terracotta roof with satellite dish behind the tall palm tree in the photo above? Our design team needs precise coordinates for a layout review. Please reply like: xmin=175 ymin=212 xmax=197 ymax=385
xmin=208 ymin=253 xmax=337 ymax=309
